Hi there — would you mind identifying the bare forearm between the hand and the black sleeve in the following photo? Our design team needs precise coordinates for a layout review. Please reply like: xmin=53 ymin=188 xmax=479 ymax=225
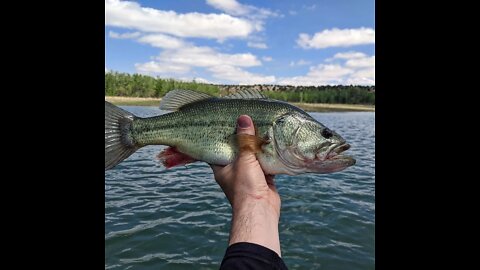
xmin=229 ymin=199 xmax=281 ymax=256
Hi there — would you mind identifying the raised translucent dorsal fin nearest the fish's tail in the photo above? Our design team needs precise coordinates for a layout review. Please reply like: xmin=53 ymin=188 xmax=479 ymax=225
xmin=160 ymin=89 xmax=212 ymax=111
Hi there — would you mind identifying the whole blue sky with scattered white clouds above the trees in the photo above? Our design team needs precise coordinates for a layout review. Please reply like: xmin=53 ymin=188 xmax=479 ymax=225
xmin=105 ymin=0 xmax=375 ymax=85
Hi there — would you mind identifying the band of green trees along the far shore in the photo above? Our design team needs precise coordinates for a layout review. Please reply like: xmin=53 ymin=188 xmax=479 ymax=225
xmin=105 ymin=72 xmax=375 ymax=105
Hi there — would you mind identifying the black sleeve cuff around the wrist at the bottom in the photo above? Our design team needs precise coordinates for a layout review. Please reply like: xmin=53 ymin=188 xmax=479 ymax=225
xmin=220 ymin=242 xmax=287 ymax=270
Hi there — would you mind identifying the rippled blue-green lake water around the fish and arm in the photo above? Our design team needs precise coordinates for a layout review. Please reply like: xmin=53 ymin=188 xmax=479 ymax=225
xmin=105 ymin=106 xmax=375 ymax=269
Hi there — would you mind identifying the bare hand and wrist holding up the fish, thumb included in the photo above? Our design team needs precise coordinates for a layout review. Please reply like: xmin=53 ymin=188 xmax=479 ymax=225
xmin=212 ymin=115 xmax=281 ymax=256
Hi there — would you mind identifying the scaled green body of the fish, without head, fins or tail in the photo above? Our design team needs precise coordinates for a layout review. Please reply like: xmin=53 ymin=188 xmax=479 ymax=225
xmin=132 ymin=99 xmax=295 ymax=163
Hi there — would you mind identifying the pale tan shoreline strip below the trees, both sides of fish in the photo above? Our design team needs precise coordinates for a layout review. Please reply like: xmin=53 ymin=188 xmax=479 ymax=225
xmin=105 ymin=96 xmax=375 ymax=112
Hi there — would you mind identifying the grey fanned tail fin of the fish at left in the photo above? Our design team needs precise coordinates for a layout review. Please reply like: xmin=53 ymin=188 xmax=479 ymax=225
xmin=105 ymin=101 xmax=139 ymax=170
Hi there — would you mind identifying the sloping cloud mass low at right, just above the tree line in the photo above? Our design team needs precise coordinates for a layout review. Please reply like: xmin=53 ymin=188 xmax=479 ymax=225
xmin=278 ymin=52 xmax=375 ymax=85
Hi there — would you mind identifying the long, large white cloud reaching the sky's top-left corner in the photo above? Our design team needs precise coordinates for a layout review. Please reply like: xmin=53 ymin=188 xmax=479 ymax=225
xmin=105 ymin=0 xmax=255 ymax=40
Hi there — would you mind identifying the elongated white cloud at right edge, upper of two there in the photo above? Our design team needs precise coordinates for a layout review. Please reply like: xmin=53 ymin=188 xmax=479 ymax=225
xmin=297 ymin=27 xmax=375 ymax=49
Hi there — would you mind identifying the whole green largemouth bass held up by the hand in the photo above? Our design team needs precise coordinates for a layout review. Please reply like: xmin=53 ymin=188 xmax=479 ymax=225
xmin=105 ymin=89 xmax=356 ymax=175
